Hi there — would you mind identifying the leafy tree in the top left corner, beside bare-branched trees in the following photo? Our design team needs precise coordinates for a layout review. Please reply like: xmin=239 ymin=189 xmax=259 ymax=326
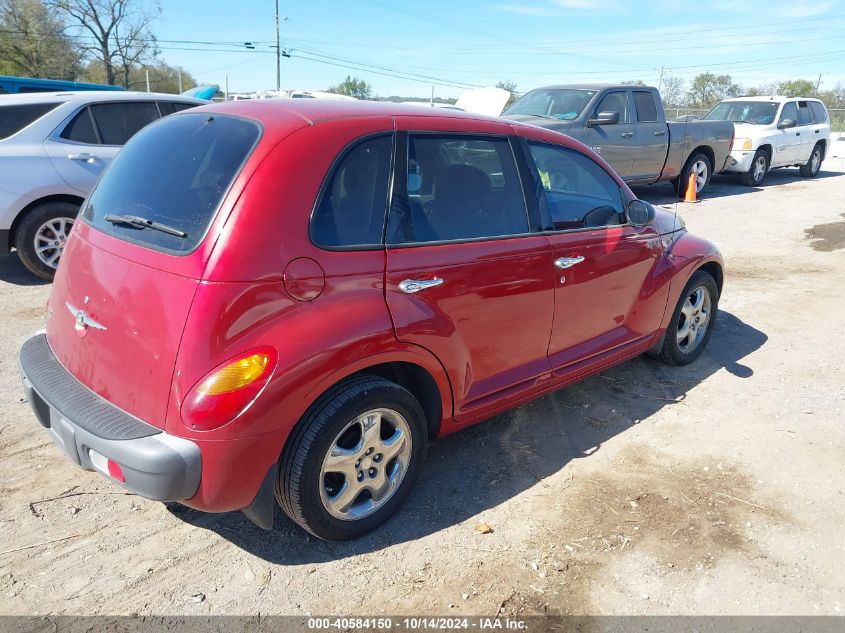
xmin=0 ymin=0 xmax=80 ymax=80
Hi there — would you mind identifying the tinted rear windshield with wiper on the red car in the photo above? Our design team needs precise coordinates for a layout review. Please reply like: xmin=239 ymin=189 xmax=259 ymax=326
xmin=82 ymin=113 xmax=261 ymax=254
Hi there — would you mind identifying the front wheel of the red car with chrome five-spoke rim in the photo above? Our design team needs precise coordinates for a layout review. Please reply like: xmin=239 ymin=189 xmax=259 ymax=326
xmin=649 ymin=270 xmax=719 ymax=365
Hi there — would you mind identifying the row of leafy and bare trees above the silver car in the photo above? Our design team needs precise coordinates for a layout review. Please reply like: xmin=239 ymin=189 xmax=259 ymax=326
xmin=0 ymin=0 xmax=196 ymax=93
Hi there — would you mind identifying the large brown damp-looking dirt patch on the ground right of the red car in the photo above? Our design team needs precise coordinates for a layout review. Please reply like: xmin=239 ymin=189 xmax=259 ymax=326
xmin=503 ymin=446 xmax=788 ymax=615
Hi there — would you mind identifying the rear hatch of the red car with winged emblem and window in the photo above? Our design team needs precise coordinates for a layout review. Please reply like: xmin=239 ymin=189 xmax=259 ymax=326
xmin=47 ymin=113 xmax=261 ymax=428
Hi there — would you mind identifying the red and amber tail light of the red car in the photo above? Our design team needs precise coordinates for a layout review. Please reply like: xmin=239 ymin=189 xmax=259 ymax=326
xmin=181 ymin=348 xmax=277 ymax=431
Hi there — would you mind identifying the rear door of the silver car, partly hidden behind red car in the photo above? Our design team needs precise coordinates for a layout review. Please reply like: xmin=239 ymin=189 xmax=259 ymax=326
xmin=44 ymin=101 xmax=161 ymax=195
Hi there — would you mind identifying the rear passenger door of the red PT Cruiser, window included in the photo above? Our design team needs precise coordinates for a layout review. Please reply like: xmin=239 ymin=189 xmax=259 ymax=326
xmin=385 ymin=126 xmax=554 ymax=420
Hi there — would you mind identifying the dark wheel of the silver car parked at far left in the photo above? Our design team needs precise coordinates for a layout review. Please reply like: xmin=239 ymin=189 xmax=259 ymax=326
xmin=15 ymin=201 xmax=79 ymax=281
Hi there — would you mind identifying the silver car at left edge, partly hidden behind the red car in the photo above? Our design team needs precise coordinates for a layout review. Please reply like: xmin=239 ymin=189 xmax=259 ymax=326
xmin=0 ymin=91 xmax=208 ymax=280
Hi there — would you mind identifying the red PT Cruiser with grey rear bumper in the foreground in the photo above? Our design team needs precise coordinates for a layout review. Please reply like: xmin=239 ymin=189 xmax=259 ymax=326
xmin=20 ymin=101 xmax=722 ymax=539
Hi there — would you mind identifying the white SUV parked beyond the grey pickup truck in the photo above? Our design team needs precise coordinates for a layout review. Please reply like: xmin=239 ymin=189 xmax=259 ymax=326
xmin=704 ymin=97 xmax=830 ymax=187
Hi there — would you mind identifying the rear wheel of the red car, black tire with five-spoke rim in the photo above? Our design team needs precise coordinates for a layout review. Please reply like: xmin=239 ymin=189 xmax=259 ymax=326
xmin=276 ymin=374 xmax=428 ymax=541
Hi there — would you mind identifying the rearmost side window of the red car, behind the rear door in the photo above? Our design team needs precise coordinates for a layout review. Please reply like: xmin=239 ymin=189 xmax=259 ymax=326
xmin=311 ymin=135 xmax=393 ymax=247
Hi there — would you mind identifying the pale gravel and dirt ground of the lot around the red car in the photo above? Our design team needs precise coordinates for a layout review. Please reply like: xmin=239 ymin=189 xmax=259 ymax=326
xmin=0 ymin=159 xmax=845 ymax=615
